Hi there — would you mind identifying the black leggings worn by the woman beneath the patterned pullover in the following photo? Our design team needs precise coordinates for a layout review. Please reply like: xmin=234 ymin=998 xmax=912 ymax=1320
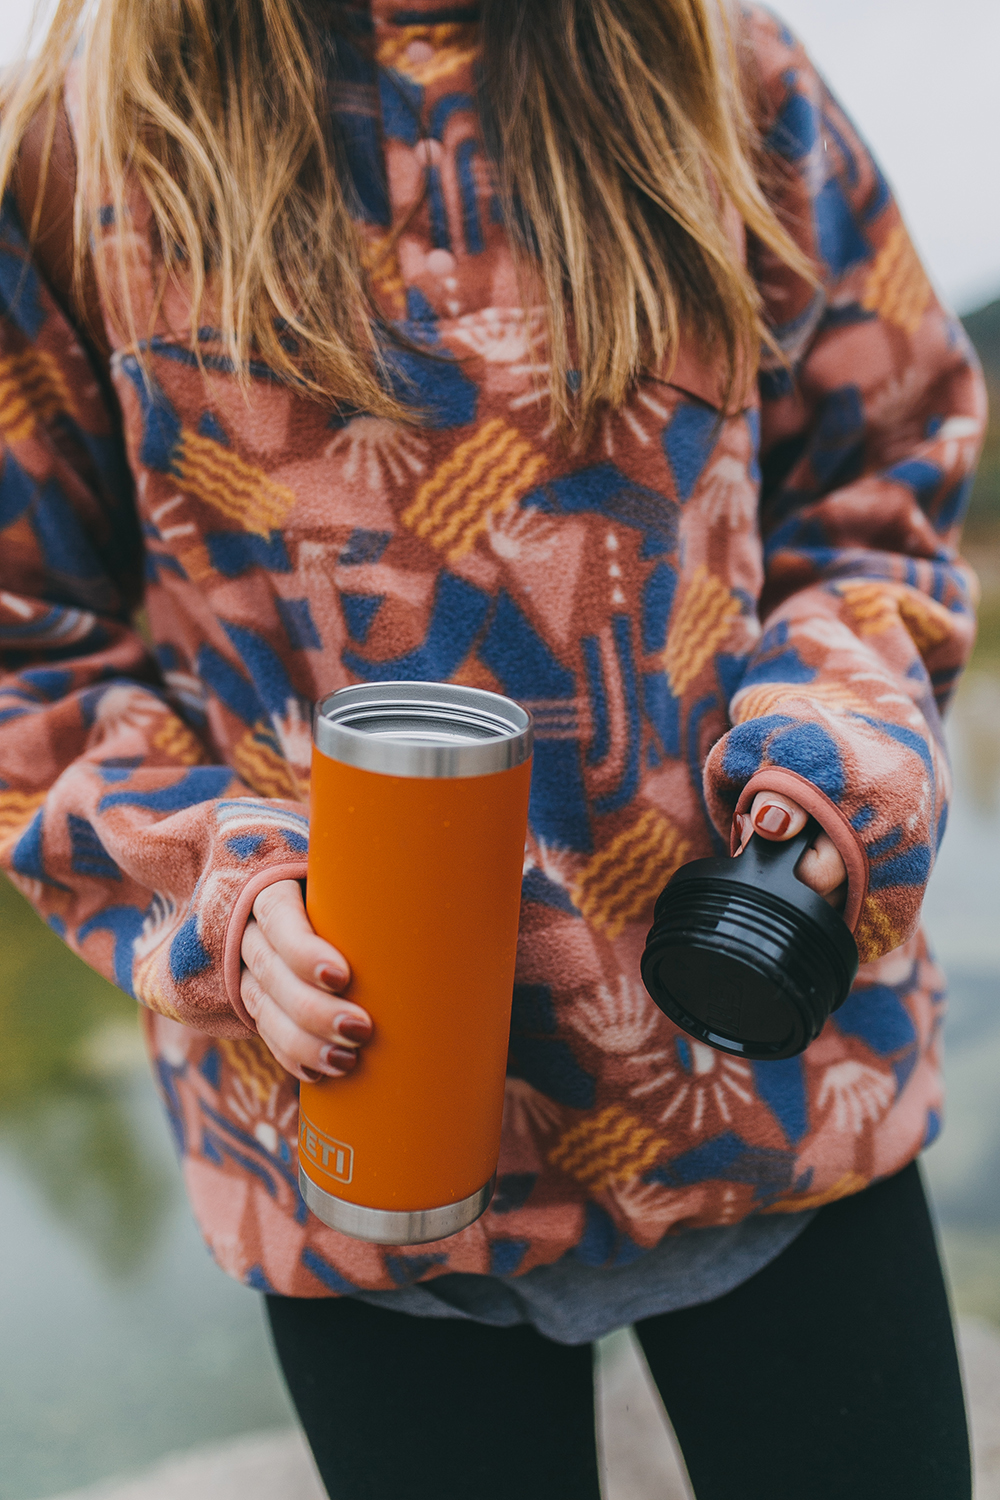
xmin=267 ymin=1166 xmax=972 ymax=1500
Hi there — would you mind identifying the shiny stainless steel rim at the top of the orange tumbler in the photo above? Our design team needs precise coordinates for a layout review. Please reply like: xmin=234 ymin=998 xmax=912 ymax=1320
xmin=313 ymin=683 xmax=534 ymax=779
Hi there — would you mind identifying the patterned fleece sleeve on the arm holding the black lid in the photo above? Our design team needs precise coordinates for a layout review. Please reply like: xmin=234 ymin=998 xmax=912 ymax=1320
xmin=706 ymin=9 xmax=985 ymax=960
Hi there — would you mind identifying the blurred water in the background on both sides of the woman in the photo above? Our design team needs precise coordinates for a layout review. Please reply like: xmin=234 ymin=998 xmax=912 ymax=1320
xmin=0 ymin=671 xmax=1000 ymax=1500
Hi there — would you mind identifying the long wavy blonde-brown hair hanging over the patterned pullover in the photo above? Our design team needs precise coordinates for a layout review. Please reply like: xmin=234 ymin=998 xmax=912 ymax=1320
xmin=0 ymin=0 xmax=811 ymax=428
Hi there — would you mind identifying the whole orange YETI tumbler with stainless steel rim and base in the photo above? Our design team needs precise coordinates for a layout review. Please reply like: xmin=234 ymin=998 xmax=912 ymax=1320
xmin=298 ymin=683 xmax=532 ymax=1245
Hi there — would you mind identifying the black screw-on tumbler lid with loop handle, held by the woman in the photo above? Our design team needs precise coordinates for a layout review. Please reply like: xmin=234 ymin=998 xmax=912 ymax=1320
xmin=642 ymin=819 xmax=858 ymax=1061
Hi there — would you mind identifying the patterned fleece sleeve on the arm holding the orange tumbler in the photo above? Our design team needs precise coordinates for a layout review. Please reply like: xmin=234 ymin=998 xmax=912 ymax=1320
xmin=0 ymin=198 xmax=307 ymax=1037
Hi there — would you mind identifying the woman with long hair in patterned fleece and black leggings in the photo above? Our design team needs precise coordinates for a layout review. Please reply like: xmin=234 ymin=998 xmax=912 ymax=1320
xmin=0 ymin=0 xmax=984 ymax=1500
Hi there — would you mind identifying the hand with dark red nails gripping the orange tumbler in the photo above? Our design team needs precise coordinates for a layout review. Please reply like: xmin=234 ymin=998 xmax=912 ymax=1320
xmin=240 ymin=881 xmax=373 ymax=1083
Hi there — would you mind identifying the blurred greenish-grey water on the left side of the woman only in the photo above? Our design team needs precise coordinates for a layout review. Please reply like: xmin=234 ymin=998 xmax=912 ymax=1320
xmin=0 ymin=881 xmax=292 ymax=1500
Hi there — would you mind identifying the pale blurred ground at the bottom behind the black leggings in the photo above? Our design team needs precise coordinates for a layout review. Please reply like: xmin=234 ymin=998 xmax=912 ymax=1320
xmin=35 ymin=1319 xmax=1000 ymax=1500
